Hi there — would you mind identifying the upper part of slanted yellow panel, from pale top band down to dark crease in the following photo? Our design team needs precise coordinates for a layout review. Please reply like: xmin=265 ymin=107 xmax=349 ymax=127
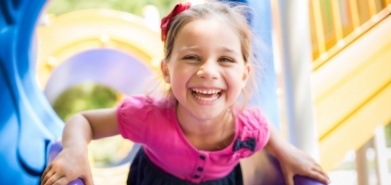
xmin=311 ymin=17 xmax=391 ymax=138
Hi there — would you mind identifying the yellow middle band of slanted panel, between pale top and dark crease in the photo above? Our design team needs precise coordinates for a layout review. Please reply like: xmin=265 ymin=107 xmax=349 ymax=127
xmin=315 ymin=46 xmax=391 ymax=137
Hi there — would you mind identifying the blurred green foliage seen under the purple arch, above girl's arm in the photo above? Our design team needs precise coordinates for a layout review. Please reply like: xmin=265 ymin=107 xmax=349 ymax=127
xmin=53 ymin=83 xmax=117 ymax=120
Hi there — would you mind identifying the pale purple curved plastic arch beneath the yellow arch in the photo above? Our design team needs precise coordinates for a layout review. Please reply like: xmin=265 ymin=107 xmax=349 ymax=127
xmin=45 ymin=48 xmax=156 ymax=102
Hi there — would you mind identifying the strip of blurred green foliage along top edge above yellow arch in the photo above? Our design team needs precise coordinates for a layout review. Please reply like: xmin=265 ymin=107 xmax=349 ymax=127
xmin=47 ymin=0 xmax=179 ymax=16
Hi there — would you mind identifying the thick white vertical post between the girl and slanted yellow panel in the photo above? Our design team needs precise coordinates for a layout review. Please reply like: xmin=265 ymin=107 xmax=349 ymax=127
xmin=271 ymin=0 xmax=319 ymax=159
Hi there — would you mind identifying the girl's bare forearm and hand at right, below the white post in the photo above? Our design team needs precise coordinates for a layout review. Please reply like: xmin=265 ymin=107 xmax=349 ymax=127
xmin=265 ymin=126 xmax=329 ymax=185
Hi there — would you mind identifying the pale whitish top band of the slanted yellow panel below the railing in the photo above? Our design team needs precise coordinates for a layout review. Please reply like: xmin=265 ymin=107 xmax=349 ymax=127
xmin=311 ymin=16 xmax=391 ymax=102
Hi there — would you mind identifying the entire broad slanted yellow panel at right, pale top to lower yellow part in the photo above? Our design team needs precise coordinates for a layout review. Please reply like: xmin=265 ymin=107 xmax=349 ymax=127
xmin=311 ymin=16 xmax=391 ymax=170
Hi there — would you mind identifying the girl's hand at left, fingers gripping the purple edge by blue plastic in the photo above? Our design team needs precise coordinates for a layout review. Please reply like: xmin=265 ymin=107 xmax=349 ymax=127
xmin=41 ymin=148 xmax=93 ymax=185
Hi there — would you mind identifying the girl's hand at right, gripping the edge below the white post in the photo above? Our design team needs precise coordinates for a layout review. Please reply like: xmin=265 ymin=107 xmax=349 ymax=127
xmin=278 ymin=145 xmax=330 ymax=185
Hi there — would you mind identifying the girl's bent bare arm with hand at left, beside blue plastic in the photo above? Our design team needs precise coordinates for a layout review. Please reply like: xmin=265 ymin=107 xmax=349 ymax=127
xmin=41 ymin=108 xmax=119 ymax=185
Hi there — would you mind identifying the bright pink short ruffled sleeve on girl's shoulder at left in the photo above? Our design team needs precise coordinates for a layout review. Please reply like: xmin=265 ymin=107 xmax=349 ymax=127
xmin=117 ymin=96 xmax=153 ymax=143
